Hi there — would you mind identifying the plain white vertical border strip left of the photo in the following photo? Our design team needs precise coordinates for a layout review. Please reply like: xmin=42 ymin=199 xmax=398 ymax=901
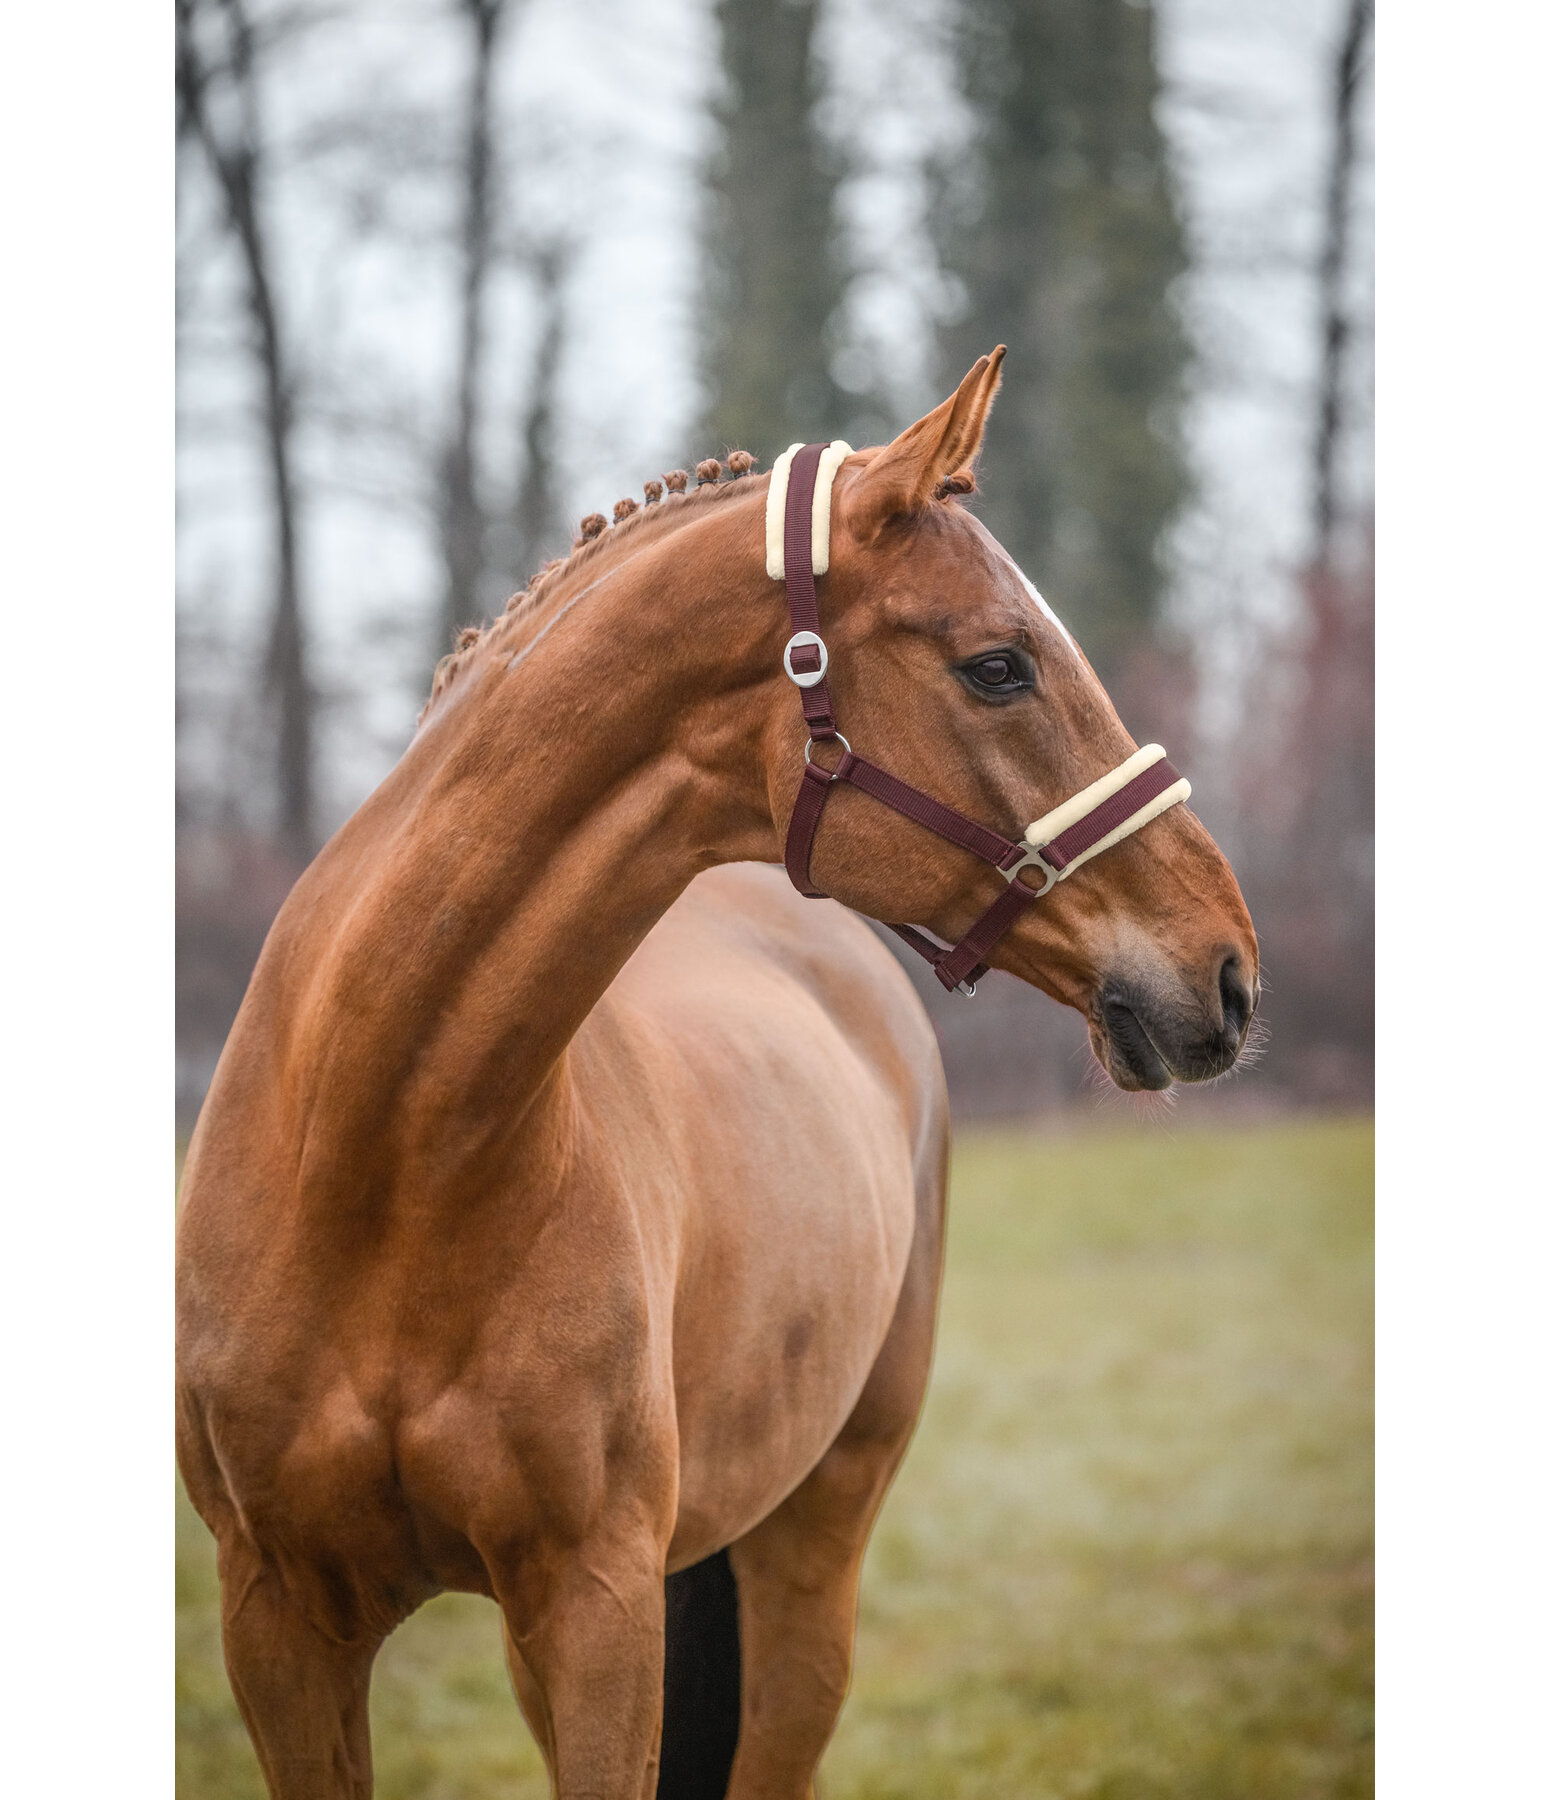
xmin=0 ymin=0 xmax=173 ymax=1796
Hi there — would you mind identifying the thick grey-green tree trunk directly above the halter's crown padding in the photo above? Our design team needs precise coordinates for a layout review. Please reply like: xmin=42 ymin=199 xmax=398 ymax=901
xmin=706 ymin=0 xmax=855 ymax=468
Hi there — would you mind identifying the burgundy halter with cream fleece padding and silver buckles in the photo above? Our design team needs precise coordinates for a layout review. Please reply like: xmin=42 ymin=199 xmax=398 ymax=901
xmin=765 ymin=441 xmax=1190 ymax=994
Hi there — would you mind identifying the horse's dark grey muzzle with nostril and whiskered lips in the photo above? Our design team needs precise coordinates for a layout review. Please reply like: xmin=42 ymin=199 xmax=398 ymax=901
xmin=1087 ymin=950 xmax=1258 ymax=1093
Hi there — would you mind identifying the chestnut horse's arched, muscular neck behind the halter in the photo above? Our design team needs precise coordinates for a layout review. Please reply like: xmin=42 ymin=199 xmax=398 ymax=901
xmin=252 ymin=497 xmax=784 ymax=1193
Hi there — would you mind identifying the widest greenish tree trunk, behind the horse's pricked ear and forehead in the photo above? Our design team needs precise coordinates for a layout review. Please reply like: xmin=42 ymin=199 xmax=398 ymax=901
xmin=934 ymin=0 xmax=1188 ymax=675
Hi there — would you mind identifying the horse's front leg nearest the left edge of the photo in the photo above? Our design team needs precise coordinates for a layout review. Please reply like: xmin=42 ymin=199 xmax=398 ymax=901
xmin=221 ymin=1544 xmax=382 ymax=1800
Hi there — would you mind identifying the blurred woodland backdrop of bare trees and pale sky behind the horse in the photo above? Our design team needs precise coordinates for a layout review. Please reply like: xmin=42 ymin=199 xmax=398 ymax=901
xmin=176 ymin=0 xmax=1374 ymax=1125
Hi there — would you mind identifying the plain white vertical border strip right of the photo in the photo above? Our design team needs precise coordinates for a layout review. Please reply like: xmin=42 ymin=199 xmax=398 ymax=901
xmin=1375 ymin=0 xmax=1550 ymax=1800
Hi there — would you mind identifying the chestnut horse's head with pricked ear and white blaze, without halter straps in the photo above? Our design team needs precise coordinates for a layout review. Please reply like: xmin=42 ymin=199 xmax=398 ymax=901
xmin=776 ymin=349 xmax=1258 ymax=1089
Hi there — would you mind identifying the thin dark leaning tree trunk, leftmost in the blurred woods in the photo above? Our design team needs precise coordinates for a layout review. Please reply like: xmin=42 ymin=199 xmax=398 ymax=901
xmin=178 ymin=0 xmax=317 ymax=862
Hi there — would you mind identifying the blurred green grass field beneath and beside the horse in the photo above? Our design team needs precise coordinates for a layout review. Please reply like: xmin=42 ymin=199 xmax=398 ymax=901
xmin=178 ymin=1121 xmax=1372 ymax=1800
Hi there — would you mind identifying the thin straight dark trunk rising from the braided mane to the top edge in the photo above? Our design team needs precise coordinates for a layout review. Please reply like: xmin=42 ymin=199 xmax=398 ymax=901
xmin=441 ymin=0 xmax=506 ymax=650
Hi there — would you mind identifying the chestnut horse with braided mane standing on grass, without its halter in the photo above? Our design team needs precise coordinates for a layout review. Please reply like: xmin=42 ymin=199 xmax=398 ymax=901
xmin=178 ymin=351 xmax=1258 ymax=1800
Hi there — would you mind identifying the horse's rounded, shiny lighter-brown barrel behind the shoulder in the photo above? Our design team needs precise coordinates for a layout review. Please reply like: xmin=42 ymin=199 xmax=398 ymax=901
xmin=578 ymin=866 xmax=947 ymax=1559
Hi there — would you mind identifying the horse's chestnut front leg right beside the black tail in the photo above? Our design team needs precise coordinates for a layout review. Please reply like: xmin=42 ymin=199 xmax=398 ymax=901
xmin=497 ymin=1544 xmax=662 ymax=1800
